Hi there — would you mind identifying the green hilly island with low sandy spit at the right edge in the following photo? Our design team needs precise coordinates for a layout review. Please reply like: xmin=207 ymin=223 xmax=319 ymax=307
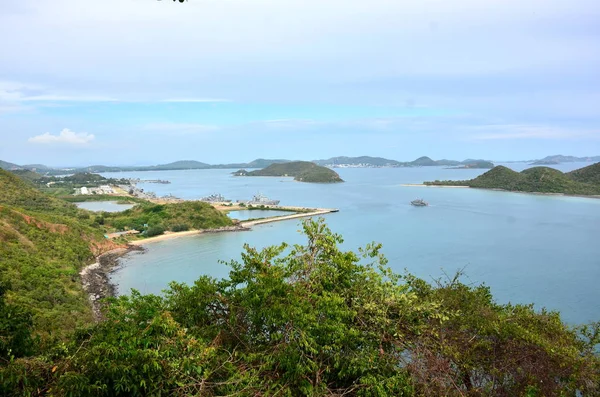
xmin=423 ymin=163 xmax=600 ymax=195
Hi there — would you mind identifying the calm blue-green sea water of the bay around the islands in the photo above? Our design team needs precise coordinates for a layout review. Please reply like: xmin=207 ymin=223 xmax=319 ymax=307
xmin=105 ymin=163 xmax=600 ymax=323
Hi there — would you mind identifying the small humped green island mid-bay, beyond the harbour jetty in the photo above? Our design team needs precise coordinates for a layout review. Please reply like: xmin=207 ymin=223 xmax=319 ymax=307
xmin=233 ymin=161 xmax=344 ymax=183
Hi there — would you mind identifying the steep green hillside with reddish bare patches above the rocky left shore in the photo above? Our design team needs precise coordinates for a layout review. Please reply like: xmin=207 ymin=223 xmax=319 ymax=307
xmin=0 ymin=170 xmax=113 ymax=345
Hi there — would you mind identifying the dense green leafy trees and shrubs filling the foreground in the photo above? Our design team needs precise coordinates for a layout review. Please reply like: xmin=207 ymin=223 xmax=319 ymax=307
xmin=0 ymin=221 xmax=600 ymax=396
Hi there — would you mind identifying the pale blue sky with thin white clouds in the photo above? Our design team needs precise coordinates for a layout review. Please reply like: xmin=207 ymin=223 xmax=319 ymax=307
xmin=0 ymin=0 xmax=600 ymax=166
